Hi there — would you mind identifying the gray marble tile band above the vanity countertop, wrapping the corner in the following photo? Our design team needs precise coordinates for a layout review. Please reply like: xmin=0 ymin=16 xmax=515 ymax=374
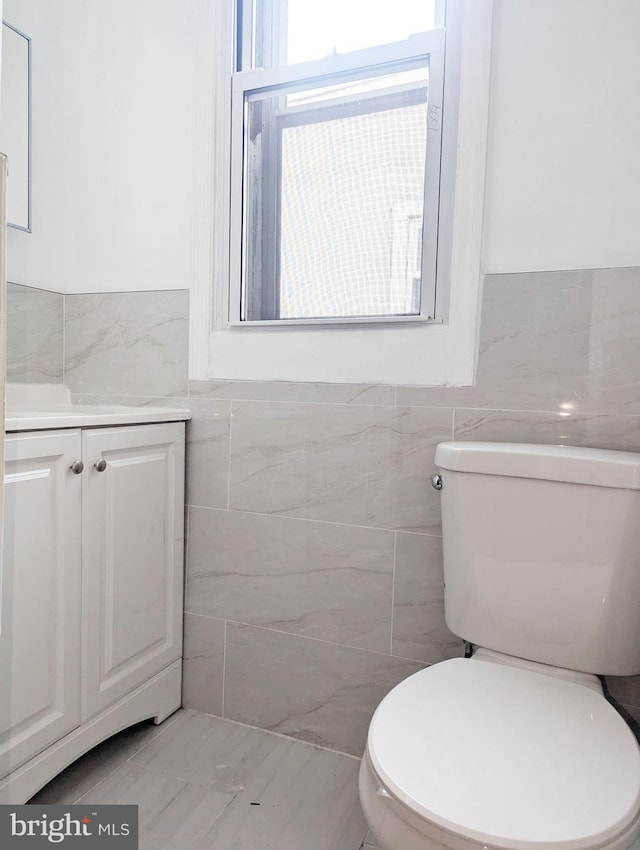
xmin=7 ymin=283 xmax=189 ymax=398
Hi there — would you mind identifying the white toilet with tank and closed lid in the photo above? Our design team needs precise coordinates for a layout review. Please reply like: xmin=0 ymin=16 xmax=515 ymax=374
xmin=360 ymin=442 xmax=640 ymax=850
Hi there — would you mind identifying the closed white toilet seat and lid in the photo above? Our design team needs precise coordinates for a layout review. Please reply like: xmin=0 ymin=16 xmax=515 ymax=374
xmin=367 ymin=658 xmax=640 ymax=850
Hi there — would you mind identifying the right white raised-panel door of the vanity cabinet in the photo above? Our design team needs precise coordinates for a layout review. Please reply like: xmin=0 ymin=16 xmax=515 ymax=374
xmin=82 ymin=422 xmax=184 ymax=717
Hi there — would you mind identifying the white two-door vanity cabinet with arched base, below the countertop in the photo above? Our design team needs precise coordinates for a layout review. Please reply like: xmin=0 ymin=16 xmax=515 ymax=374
xmin=0 ymin=421 xmax=184 ymax=803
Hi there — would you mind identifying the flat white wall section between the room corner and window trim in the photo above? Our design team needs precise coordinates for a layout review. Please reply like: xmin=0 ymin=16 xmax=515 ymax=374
xmin=64 ymin=0 xmax=200 ymax=292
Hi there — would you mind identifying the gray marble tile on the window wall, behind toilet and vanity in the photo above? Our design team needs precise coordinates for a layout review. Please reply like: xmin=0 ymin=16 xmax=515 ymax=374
xmin=50 ymin=269 xmax=640 ymax=753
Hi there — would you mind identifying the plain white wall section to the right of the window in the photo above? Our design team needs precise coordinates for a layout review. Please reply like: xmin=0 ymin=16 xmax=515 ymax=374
xmin=483 ymin=0 xmax=640 ymax=273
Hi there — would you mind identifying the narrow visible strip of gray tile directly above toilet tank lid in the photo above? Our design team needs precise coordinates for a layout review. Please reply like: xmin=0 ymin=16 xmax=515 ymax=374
xmin=454 ymin=409 xmax=640 ymax=452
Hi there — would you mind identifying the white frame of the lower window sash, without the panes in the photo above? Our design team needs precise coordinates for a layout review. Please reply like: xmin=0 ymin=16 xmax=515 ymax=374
xmin=229 ymin=29 xmax=445 ymax=327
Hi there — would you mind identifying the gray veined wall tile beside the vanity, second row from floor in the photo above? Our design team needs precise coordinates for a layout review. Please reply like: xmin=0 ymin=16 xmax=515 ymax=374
xmin=186 ymin=508 xmax=394 ymax=652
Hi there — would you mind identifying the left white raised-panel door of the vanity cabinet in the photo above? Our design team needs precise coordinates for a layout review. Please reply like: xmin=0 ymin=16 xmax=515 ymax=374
xmin=0 ymin=431 xmax=83 ymax=776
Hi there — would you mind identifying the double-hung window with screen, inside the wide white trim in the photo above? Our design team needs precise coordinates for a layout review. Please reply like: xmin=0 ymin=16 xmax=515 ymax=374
xmin=229 ymin=0 xmax=445 ymax=325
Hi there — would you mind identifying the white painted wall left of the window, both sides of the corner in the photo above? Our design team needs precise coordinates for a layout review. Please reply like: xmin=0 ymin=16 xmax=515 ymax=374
xmin=5 ymin=0 xmax=198 ymax=292
